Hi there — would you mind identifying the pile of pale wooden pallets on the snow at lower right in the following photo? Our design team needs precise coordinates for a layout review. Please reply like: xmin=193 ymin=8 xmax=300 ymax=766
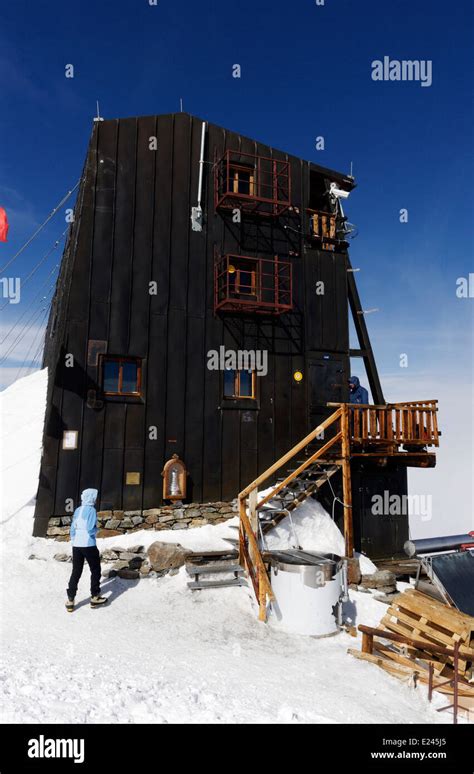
xmin=377 ymin=589 xmax=474 ymax=679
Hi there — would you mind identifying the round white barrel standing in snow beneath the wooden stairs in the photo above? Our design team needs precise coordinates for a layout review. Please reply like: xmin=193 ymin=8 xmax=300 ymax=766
xmin=268 ymin=554 xmax=342 ymax=637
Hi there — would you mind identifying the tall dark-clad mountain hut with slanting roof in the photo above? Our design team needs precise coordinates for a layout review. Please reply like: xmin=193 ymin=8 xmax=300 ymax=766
xmin=35 ymin=113 xmax=407 ymax=554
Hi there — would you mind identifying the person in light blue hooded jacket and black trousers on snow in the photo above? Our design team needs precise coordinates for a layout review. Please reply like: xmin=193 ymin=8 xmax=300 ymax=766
xmin=66 ymin=489 xmax=107 ymax=612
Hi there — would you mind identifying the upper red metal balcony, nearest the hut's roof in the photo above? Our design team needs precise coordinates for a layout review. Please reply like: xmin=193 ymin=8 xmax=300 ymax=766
xmin=214 ymin=150 xmax=291 ymax=217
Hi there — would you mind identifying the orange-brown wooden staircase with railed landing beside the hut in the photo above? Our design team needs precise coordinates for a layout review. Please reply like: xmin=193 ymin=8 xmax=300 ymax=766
xmin=238 ymin=401 xmax=440 ymax=621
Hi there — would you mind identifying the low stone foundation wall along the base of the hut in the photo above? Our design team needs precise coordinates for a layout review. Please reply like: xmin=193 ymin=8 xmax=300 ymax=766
xmin=47 ymin=502 xmax=237 ymax=541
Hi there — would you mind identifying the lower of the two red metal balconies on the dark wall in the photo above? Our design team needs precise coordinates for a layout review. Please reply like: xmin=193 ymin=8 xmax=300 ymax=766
xmin=214 ymin=255 xmax=293 ymax=314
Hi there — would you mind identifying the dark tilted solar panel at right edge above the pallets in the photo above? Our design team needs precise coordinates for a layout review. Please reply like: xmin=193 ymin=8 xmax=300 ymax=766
xmin=431 ymin=551 xmax=474 ymax=616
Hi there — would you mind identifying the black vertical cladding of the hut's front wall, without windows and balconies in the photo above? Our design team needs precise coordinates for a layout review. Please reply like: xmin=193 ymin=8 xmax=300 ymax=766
xmin=35 ymin=113 xmax=356 ymax=534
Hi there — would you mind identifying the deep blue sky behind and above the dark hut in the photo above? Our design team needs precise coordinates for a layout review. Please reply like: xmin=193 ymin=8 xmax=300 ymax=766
xmin=0 ymin=0 xmax=474 ymax=531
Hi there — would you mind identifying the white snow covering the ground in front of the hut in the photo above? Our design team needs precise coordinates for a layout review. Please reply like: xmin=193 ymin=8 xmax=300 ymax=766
xmin=0 ymin=372 xmax=451 ymax=724
